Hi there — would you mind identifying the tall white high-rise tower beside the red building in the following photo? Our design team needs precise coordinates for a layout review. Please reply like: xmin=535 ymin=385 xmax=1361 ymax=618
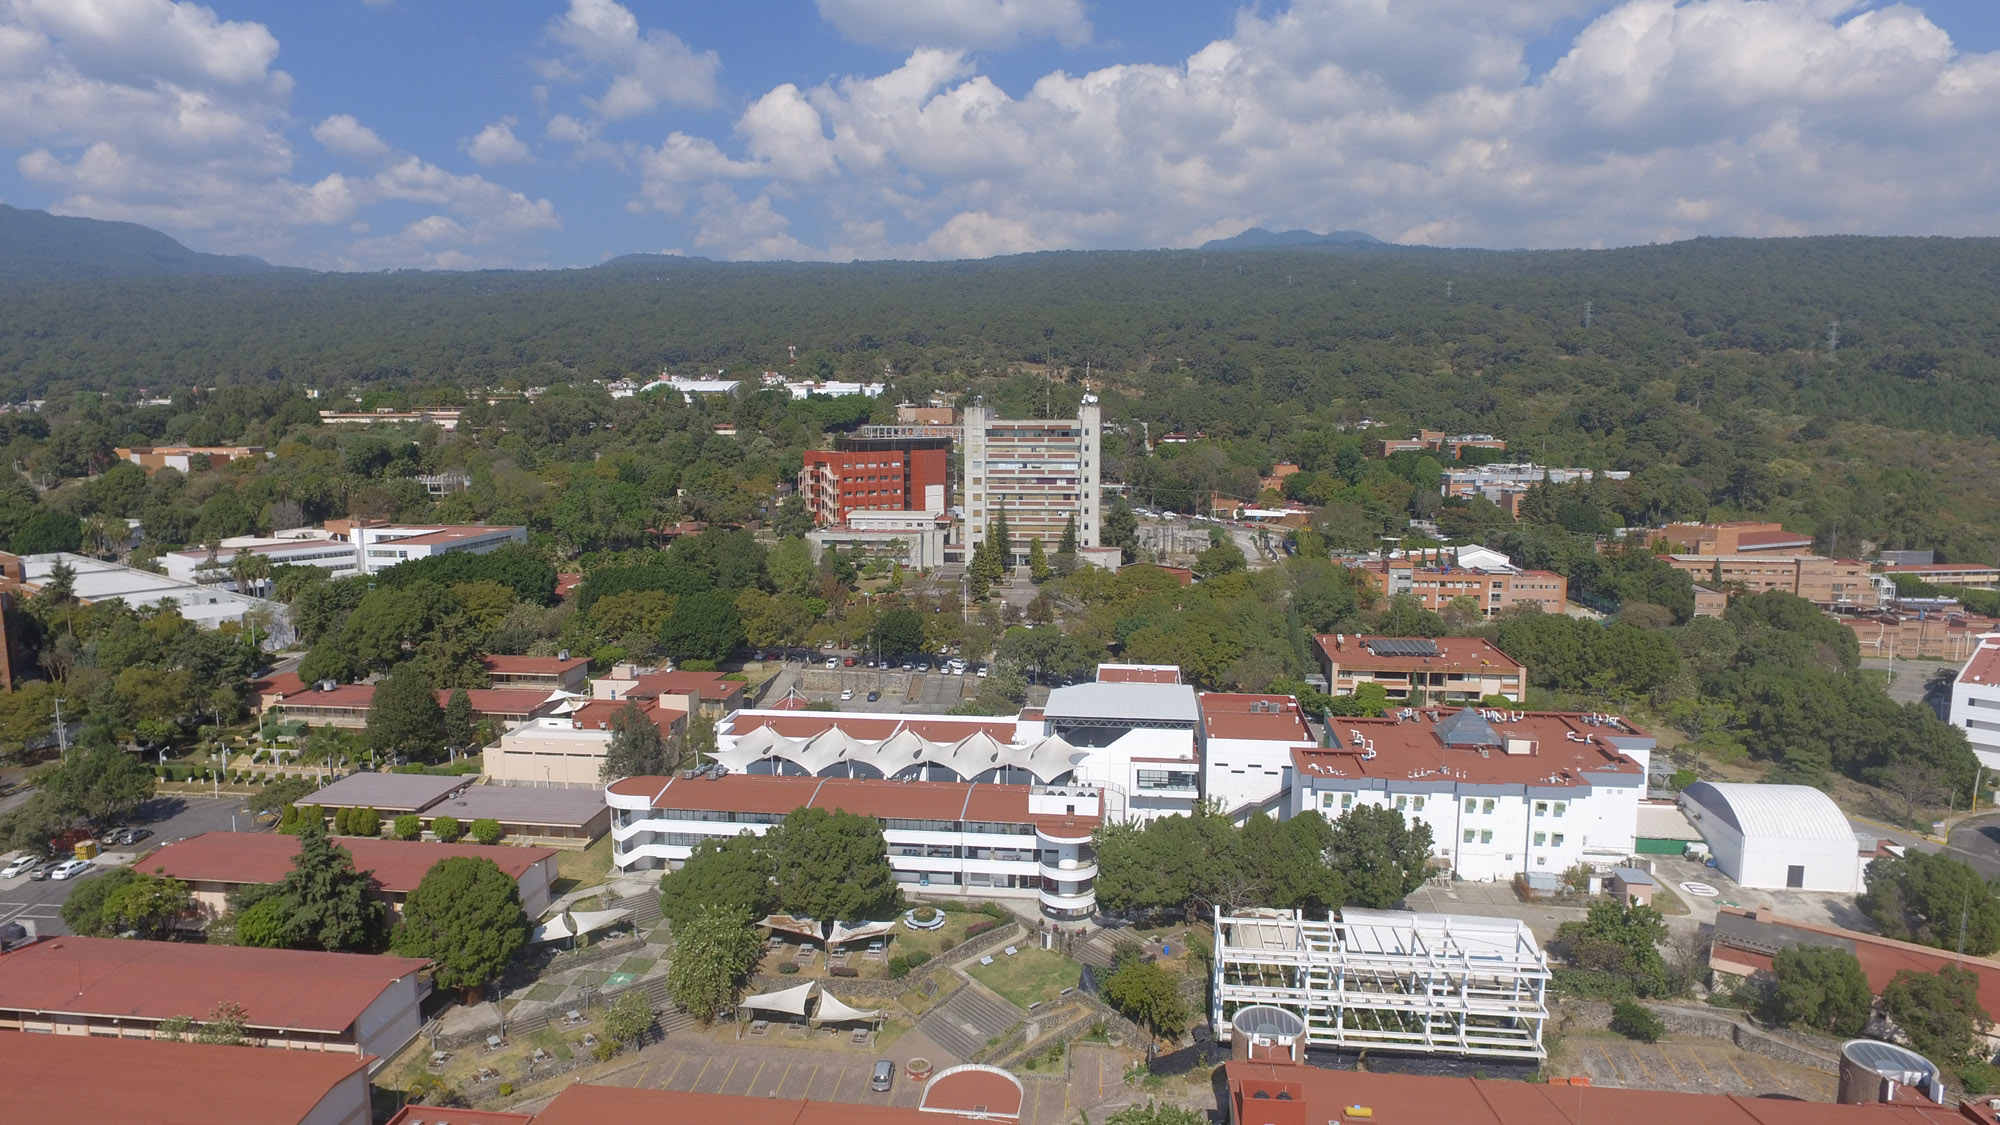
xmin=964 ymin=398 xmax=1104 ymax=563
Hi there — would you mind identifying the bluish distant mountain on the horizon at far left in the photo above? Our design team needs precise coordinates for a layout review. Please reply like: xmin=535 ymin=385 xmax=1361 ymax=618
xmin=0 ymin=204 xmax=292 ymax=284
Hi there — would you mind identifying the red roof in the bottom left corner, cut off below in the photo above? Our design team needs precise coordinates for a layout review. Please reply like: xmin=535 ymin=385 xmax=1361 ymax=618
xmin=0 ymin=1007 xmax=374 ymax=1125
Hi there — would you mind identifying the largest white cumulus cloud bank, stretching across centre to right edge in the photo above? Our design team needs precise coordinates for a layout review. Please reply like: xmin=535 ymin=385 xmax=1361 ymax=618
xmin=616 ymin=0 xmax=2000 ymax=258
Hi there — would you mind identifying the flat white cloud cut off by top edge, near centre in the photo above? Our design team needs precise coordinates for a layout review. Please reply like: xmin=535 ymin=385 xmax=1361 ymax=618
xmin=816 ymin=0 xmax=1090 ymax=48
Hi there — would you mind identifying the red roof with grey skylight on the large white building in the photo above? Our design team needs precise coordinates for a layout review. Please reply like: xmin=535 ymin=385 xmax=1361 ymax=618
xmin=1292 ymin=709 xmax=1652 ymax=789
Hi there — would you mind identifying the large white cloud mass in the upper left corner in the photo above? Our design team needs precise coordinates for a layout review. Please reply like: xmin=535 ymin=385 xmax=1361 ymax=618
xmin=0 ymin=0 xmax=560 ymax=268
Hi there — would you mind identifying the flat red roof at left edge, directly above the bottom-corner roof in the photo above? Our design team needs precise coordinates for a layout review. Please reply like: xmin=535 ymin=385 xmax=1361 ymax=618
xmin=0 ymin=937 xmax=426 ymax=1035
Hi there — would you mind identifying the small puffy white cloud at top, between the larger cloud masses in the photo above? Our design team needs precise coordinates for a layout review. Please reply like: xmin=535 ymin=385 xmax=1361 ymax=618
xmin=540 ymin=0 xmax=722 ymax=120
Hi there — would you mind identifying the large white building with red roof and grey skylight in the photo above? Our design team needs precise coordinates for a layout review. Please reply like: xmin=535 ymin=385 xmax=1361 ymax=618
xmin=1286 ymin=707 xmax=1654 ymax=883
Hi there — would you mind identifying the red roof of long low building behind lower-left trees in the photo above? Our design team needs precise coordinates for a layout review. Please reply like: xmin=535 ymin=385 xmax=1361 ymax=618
xmin=145 ymin=833 xmax=556 ymax=895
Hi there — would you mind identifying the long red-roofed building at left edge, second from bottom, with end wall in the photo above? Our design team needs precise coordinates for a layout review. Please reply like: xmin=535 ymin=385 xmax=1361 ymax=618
xmin=0 ymin=937 xmax=428 ymax=1056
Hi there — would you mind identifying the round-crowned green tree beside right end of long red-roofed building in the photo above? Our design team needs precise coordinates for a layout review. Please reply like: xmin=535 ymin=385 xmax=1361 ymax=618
xmin=390 ymin=855 xmax=528 ymax=995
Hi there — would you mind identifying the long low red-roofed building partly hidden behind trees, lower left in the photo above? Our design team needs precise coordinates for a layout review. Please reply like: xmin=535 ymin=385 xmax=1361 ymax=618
xmin=138 ymin=833 xmax=556 ymax=925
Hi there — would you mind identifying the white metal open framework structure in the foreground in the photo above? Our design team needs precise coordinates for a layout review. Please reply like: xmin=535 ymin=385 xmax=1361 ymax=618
xmin=1210 ymin=907 xmax=1548 ymax=1059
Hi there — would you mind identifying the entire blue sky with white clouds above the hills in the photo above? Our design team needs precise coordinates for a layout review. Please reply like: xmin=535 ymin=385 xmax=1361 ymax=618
xmin=0 ymin=0 xmax=2000 ymax=270
